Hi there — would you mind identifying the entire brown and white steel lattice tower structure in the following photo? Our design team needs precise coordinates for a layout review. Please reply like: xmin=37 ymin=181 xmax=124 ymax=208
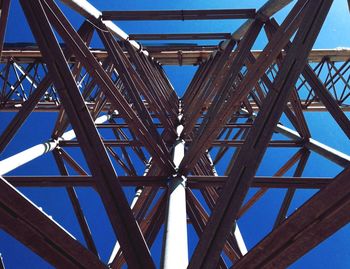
xmin=0 ymin=0 xmax=350 ymax=269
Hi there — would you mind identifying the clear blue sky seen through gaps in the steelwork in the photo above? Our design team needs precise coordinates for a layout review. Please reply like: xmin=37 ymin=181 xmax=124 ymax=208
xmin=0 ymin=0 xmax=350 ymax=269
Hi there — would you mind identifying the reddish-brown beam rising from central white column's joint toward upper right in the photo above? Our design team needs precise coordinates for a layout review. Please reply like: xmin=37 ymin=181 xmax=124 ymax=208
xmin=180 ymin=2 xmax=304 ymax=172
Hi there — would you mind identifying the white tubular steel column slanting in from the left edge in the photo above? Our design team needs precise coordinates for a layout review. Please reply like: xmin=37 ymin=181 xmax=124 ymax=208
xmin=0 ymin=115 xmax=110 ymax=176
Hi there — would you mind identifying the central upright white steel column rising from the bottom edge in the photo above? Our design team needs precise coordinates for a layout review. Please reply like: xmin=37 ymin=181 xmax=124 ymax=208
xmin=162 ymin=101 xmax=188 ymax=269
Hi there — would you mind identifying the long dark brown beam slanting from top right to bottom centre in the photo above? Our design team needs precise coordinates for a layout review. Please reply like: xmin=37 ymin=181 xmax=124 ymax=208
xmin=189 ymin=0 xmax=332 ymax=269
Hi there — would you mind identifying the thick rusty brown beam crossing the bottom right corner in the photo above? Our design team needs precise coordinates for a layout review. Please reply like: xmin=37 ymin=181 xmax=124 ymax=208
xmin=233 ymin=168 xmax=350 ymax=269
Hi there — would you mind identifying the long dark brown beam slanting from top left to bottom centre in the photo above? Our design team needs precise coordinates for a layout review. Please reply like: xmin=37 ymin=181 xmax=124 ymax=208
xmin=20 ymin=0 xmax=154 ymax=268
